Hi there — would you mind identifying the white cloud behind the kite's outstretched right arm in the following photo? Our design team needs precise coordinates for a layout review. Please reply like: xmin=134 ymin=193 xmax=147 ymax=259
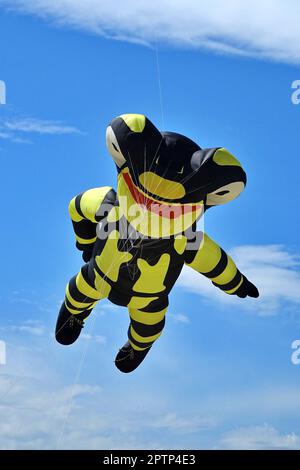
xmin=178 ymin=245 xmax=300 ymax=315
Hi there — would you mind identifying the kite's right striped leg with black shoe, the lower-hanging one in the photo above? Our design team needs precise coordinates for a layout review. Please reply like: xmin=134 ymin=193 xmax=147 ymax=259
xmin=115 ymin=307 xmax=167 ymax=372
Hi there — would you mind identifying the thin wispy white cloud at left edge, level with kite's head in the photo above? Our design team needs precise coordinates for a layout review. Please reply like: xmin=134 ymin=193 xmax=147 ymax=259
xmin=4 ymin=118 xmax=80 ymax=135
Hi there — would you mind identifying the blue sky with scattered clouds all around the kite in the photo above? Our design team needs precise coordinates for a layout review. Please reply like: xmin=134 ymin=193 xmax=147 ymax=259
xmin=0 ymin=0 xmax=300 ymax=449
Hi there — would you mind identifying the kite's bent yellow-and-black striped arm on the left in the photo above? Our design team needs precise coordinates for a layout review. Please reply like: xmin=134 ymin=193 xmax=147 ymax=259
xmin=69 ymin=186 xmax=115 ymax=261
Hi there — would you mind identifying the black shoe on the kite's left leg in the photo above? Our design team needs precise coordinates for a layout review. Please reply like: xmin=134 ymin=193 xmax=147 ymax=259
xmin=55 ymin=303 xmax=91 ymax=346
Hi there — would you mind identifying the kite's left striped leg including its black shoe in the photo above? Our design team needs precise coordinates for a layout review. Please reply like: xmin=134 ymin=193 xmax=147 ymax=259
xmin=55 ymin=264 xmax=110 ymax=345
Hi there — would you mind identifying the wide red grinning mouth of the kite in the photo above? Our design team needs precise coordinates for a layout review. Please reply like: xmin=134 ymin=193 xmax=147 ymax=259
xmin=122 ymin=173 xmax=200 ymax=219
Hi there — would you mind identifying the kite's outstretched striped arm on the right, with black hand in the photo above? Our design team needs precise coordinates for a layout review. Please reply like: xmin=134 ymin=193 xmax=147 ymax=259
xmin=186 ymin=234 xmax=259 ymax=297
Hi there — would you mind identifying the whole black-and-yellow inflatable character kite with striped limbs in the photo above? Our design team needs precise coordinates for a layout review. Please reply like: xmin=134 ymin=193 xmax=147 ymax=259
xmin=56 ymin=114 xmax=259 ymax=372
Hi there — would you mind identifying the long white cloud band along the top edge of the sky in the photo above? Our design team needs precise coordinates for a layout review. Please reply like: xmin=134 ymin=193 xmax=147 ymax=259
xmin=0 ymin=0 xmax=300 ymax=63
